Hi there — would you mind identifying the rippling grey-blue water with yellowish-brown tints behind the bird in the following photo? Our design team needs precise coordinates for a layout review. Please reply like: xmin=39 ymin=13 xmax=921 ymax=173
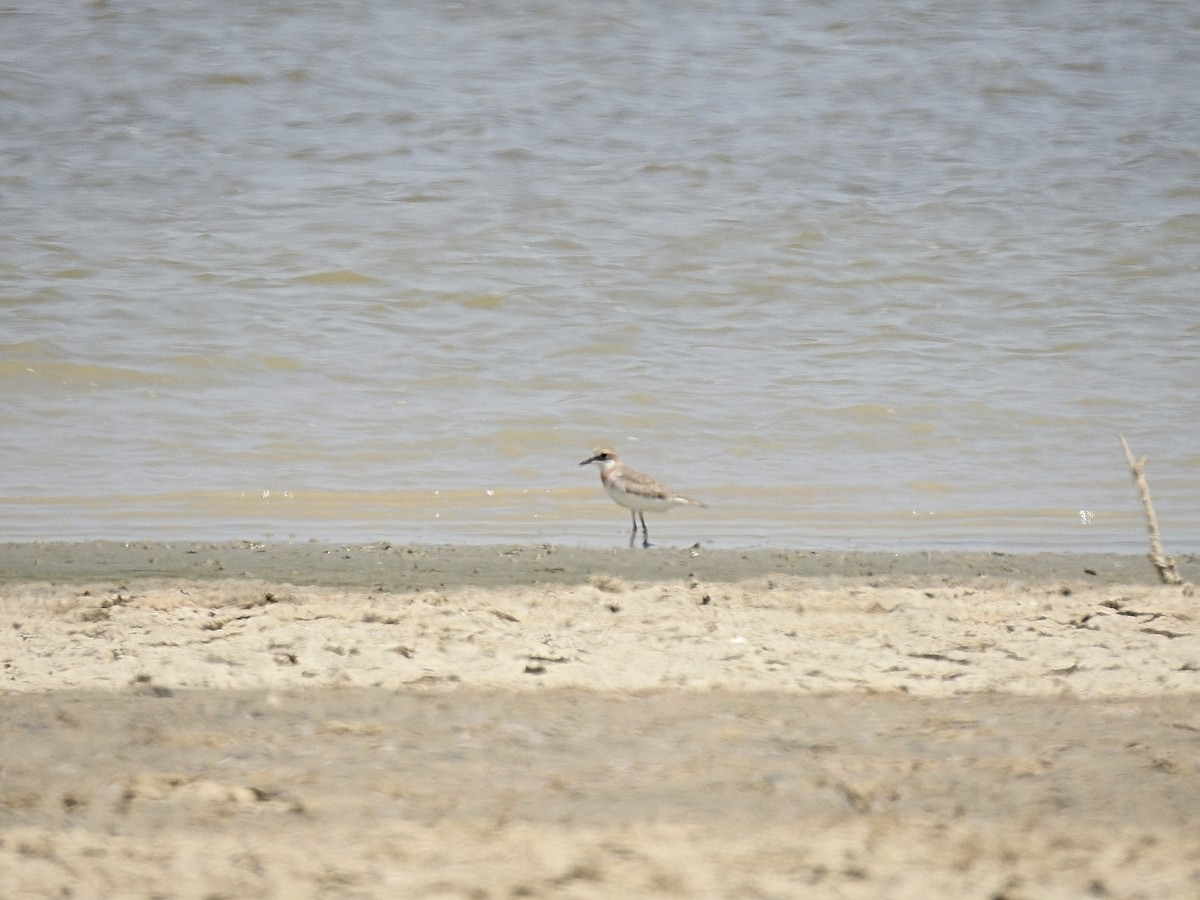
xmin=0 ymin=0 xmax=1200 ymax=552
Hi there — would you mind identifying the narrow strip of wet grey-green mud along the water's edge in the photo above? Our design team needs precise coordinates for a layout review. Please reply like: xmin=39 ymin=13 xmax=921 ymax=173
xmin=0 ymin=540 xmax=1180 ymax=592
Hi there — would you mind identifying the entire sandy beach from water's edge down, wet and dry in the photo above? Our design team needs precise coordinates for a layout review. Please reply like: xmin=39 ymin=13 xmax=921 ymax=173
xmin=0 ymin=544 xmax=1200 ymax=900
